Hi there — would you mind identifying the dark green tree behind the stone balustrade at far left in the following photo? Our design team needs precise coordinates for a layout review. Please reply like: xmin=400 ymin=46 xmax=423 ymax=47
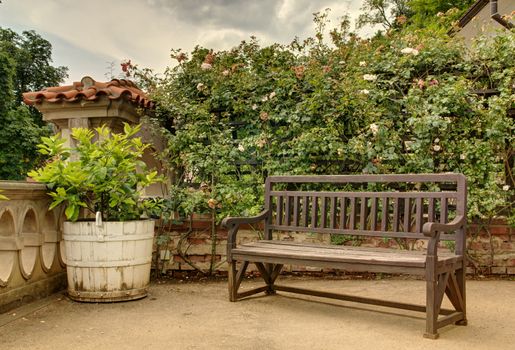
xmin=0 ymin=27 xmax=67 ymax=180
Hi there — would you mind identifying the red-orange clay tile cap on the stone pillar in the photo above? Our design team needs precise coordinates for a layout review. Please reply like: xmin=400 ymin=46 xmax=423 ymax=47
xmin=23 ymin=77 xmax=154 ymax=108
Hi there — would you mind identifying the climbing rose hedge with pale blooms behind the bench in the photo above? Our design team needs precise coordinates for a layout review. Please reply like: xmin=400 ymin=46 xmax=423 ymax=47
xmin=147 ymin=14 xmax=515 ymax=224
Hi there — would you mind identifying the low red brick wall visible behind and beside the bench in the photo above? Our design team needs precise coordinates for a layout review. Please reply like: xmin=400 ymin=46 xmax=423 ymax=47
xmin=160 ymin=219 xmax=515 ymax=275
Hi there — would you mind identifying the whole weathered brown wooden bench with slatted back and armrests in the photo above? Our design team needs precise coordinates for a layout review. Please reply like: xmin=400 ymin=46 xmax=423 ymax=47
xmin=222 ymin=174 xmax=467 ymax=339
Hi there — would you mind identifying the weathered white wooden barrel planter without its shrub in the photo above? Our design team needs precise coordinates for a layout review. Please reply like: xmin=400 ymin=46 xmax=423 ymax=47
xmin=63 ymin=220 xmax=154 ymax=302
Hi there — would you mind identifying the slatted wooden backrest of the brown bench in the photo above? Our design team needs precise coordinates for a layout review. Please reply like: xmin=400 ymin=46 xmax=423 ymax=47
xmin=265 ymin=173 xmax=467 ymax=241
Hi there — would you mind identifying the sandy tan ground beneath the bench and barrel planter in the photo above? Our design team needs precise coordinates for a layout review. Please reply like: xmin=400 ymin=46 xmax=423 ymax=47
xmin=0 ymin=278 xmax=515 ymax=350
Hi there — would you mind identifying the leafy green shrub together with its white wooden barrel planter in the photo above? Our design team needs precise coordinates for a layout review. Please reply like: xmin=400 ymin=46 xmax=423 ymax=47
xmin=29 ymin=124 xmax=160 ymax=302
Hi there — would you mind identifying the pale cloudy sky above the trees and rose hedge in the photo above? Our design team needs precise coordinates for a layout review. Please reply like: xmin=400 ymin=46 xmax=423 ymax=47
xmin=0 ymin=0 xmax=378 ymax=82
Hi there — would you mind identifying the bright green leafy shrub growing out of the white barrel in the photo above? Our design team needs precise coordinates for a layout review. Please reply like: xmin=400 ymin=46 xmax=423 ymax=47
xmin=29 ymin=124 xmax=159 ymax=221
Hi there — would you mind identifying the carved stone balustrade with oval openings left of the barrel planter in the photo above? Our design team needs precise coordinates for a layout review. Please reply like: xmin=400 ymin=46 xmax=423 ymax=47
xmin=0 ymin=181 xmax=66 ymax=313
